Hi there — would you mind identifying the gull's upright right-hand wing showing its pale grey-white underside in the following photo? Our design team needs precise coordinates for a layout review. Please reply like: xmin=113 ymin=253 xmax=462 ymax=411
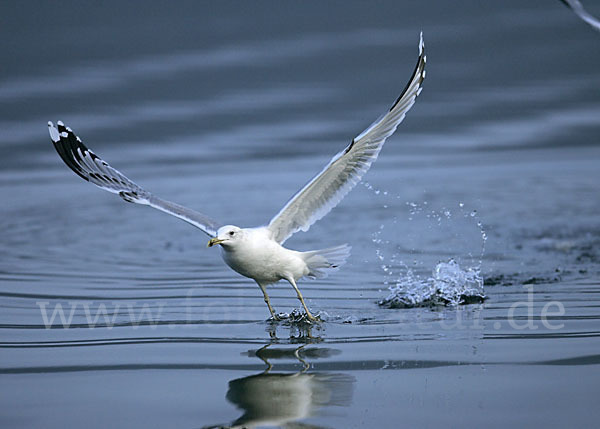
xmin=268 ymin=33 xmax=425 ymax=243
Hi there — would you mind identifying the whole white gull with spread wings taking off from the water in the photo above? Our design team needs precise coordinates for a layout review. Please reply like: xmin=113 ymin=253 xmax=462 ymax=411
xmin=48 ymin=33 xmax=426 ymax=322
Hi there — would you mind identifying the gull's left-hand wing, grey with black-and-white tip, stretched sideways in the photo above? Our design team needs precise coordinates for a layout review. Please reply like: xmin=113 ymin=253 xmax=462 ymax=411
xmin=48 ymin=121 xmax=219 ymax=236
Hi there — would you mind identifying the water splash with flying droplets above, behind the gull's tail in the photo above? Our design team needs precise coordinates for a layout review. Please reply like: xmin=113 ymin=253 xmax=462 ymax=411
xmin=363 ymin=183 xmax=488 ymax=308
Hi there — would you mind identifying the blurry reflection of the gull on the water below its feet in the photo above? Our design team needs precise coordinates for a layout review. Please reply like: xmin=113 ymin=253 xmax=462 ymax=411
xmin=210 ymin=344 xmax=354 ymax=428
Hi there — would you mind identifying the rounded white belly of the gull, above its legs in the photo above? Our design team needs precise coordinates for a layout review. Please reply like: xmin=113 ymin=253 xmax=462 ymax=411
xmin=222 ymin=241 xmax=308 ymax=284
